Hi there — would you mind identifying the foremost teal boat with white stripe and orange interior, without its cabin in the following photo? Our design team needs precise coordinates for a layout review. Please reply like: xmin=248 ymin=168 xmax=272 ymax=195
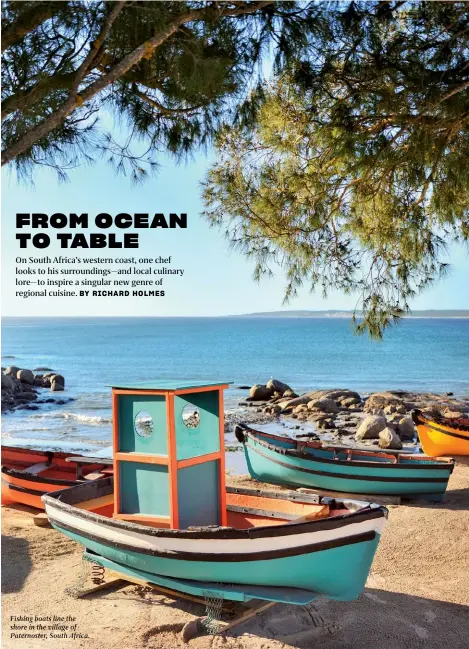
xmin=42 ymin=477 xmax=387 ymax=602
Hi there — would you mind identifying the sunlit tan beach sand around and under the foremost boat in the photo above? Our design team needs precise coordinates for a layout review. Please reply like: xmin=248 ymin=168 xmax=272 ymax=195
xmin=2 ymin=464 xmax=469 ymax=649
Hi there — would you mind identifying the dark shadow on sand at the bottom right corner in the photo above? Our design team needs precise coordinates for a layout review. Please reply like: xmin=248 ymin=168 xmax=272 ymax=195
xmin=228 ymin=588 xmax=469 ymax=649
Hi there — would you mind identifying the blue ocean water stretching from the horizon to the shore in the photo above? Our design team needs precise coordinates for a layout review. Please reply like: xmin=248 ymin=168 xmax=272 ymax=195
xmin=2 ymin=317 xmax=469 ymax=456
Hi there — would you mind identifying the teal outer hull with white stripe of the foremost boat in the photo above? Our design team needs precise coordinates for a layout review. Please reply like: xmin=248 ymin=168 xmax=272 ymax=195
xmin=45 ymin=478 xmax=386 ymax=600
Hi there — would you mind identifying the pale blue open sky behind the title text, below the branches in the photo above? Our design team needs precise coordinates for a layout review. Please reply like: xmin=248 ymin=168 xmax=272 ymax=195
xmin=2 ymin=149 xmax=469 ymax=316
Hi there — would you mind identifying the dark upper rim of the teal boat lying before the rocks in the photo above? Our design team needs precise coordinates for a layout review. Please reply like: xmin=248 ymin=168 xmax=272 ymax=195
xmin=238 ymin=426 xmax=454 ymax=470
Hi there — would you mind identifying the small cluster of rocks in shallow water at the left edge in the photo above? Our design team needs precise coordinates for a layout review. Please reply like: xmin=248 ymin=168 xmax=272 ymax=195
xmin=2 ymin=365 xmax=73 ymax=413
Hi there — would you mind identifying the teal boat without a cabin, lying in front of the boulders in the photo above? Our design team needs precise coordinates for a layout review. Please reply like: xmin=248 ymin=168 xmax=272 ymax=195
xmin=235 ymin=424 xmax=454 ymax=501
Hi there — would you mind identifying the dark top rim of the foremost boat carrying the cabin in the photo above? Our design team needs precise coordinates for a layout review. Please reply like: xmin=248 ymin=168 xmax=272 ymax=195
xmin=41 ymin=476 xmax=388 ymax=540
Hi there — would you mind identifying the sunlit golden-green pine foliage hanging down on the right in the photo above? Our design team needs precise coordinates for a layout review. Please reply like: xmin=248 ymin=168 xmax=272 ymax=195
xmin=204 ymin=2 xmax=469 ymax=339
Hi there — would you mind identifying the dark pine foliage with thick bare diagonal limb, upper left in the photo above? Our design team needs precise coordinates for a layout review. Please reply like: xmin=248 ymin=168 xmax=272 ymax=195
xmin=2 ymin=0 xmax=318 ymax=181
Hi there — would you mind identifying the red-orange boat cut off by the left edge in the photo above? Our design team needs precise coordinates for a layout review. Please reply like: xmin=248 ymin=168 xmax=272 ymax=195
xmin=2 ymin=446 xmax=112 ymax=509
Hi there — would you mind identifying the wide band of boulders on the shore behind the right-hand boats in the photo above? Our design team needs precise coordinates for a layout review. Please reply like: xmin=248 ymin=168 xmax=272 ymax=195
xmin=236 ymin=379 xmax=469 ymax=449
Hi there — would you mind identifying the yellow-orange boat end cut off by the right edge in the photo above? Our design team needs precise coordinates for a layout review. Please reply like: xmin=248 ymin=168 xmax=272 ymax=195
xmin=412 ymin=410 xmax=469 ymax=455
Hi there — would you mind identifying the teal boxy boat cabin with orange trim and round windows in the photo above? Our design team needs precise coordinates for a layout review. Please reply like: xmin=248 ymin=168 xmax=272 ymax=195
xmin=111 ymin=381 xmax=228 ymax=529
